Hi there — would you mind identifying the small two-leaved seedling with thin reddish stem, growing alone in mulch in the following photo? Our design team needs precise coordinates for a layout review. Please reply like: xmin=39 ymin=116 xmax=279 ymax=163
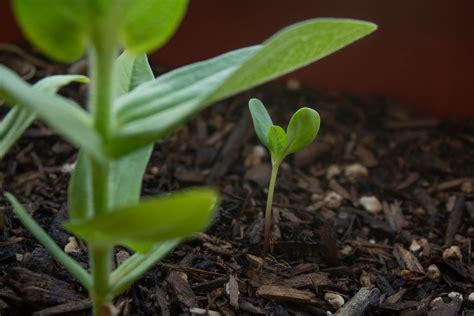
xmin=249 ymin=99 xmax=320 ymax=255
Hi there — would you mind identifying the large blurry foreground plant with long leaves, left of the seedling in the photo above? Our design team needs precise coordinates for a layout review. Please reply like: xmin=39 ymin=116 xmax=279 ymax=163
xmin=0 ymin=0 xmax=376 ymax=315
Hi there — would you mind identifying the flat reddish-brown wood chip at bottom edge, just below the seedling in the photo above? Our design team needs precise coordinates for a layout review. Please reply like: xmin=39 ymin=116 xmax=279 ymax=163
xmin=257 ymin=285 xmax=317 ymax=304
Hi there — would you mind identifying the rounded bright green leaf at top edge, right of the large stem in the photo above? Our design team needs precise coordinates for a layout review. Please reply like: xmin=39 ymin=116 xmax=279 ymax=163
xmin=120 ymin=0 xmax=188 ymax=53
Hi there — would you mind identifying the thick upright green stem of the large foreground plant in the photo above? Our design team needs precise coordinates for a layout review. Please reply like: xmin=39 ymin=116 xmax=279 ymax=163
xmin=88 ymin=27 xmax=118 ymax=316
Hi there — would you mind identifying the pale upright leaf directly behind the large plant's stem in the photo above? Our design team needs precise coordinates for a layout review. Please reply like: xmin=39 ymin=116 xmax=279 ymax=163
xmin=68 ymin=51 xmax=154 ymax=220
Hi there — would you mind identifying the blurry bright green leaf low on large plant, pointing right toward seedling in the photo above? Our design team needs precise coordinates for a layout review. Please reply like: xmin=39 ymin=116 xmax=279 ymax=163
xmin=65 ymin=188 xmax=219 ymax=252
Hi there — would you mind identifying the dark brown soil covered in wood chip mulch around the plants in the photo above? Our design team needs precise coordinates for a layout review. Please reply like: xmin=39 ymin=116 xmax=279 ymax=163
xmin=0 ymin=47 xmax=474 ymax=315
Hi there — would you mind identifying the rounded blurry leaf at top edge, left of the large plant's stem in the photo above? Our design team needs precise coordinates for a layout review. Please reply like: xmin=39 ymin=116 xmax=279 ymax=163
xmin=13 ymin=0 xmax=87 ymax=62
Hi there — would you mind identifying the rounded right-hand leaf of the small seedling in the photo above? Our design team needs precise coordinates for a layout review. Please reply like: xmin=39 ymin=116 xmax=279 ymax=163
xmin=285 ymin=108 xmax=320 ymax=154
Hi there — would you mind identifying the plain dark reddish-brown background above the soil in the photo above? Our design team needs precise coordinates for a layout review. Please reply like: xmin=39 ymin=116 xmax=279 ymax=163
xmin=0 ymin=0 xmax=474 ymax=117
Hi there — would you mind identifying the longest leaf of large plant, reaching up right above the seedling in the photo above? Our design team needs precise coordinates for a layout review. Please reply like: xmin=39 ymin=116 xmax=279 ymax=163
xmin=108 ymin=19 xmax=376 ymax=156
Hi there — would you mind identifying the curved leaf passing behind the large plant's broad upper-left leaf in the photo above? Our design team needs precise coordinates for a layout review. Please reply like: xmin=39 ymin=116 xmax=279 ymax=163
xmin=0 ymin=75 xmax=89 ymax=158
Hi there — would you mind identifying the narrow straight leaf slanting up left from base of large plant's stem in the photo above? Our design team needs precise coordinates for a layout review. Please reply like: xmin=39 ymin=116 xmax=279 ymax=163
xmin=5 ymin=193 xmax=92 ymax=289
